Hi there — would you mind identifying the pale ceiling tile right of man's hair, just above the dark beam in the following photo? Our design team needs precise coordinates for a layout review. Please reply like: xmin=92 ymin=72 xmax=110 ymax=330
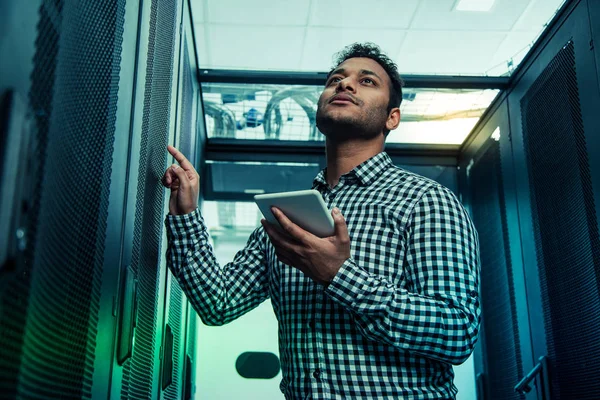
xmin=396 ymin=31 xmax=506 ymax=75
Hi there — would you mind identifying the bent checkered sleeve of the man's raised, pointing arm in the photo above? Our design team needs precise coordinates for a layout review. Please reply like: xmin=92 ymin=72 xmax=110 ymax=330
xmin=165 ymin=209 xmax=269 ymax=325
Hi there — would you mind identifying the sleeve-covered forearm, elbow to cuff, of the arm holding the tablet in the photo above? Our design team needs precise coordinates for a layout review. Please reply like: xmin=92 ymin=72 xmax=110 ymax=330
xmin=326 ymin=260 xmax=479 ymax=364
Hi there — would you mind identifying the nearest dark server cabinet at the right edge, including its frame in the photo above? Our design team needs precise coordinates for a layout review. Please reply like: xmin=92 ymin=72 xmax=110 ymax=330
xmin=508 ymin=1 xmax=600 ymax=399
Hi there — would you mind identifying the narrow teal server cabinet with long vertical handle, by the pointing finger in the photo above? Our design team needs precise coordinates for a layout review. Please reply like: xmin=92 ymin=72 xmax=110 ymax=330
xmin=111 ymin=0 xmax=181 ymax=398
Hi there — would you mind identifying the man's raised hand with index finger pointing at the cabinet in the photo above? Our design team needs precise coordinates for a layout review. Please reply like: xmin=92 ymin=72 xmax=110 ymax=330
xmin=162 ymin=146 xmax=200 ymax=215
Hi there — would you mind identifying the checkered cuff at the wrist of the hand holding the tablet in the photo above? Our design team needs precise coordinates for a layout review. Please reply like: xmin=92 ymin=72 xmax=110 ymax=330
xmin=325 ymin=258 xmax=374 ymax=311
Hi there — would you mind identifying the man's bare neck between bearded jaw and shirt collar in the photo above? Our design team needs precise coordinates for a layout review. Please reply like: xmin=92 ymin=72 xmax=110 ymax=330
xmin=326 ymin=135 xmax=384 ymax=187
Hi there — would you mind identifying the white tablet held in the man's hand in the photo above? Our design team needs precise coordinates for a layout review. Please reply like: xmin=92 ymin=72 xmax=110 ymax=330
xmin=254 ymin=189 xmax=334 ymax=237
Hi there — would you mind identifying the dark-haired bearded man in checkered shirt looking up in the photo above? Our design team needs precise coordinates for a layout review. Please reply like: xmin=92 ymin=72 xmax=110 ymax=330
xmin=163 ymin=44 xmax=480 ymax=399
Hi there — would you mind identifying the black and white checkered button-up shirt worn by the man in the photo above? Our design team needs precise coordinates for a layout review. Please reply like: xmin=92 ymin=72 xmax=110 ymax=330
xmin=165 ymin=152 xmax=480 ymax=399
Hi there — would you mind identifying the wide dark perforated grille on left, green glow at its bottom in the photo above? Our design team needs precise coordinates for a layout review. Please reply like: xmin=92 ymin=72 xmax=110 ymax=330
xmin=2 ymin=0 xmax=124 ymax=398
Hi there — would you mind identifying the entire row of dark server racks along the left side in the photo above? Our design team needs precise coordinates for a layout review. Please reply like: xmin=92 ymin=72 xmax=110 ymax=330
xmin=0 ymin=0 xmax=199 ymax=398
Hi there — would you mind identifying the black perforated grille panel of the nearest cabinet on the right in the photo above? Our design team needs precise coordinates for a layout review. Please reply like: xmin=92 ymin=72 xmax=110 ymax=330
xmin=521 ymin=42 xmax=600 ymax=400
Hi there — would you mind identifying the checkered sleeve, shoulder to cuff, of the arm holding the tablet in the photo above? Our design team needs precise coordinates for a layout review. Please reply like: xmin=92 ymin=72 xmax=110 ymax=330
xmin=326 ymin=186 xmax=480 ymax=364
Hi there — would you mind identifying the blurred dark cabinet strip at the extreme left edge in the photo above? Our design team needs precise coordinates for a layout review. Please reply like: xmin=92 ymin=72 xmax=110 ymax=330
xmin=0 ymin=1 xmax=42 ymax=398
